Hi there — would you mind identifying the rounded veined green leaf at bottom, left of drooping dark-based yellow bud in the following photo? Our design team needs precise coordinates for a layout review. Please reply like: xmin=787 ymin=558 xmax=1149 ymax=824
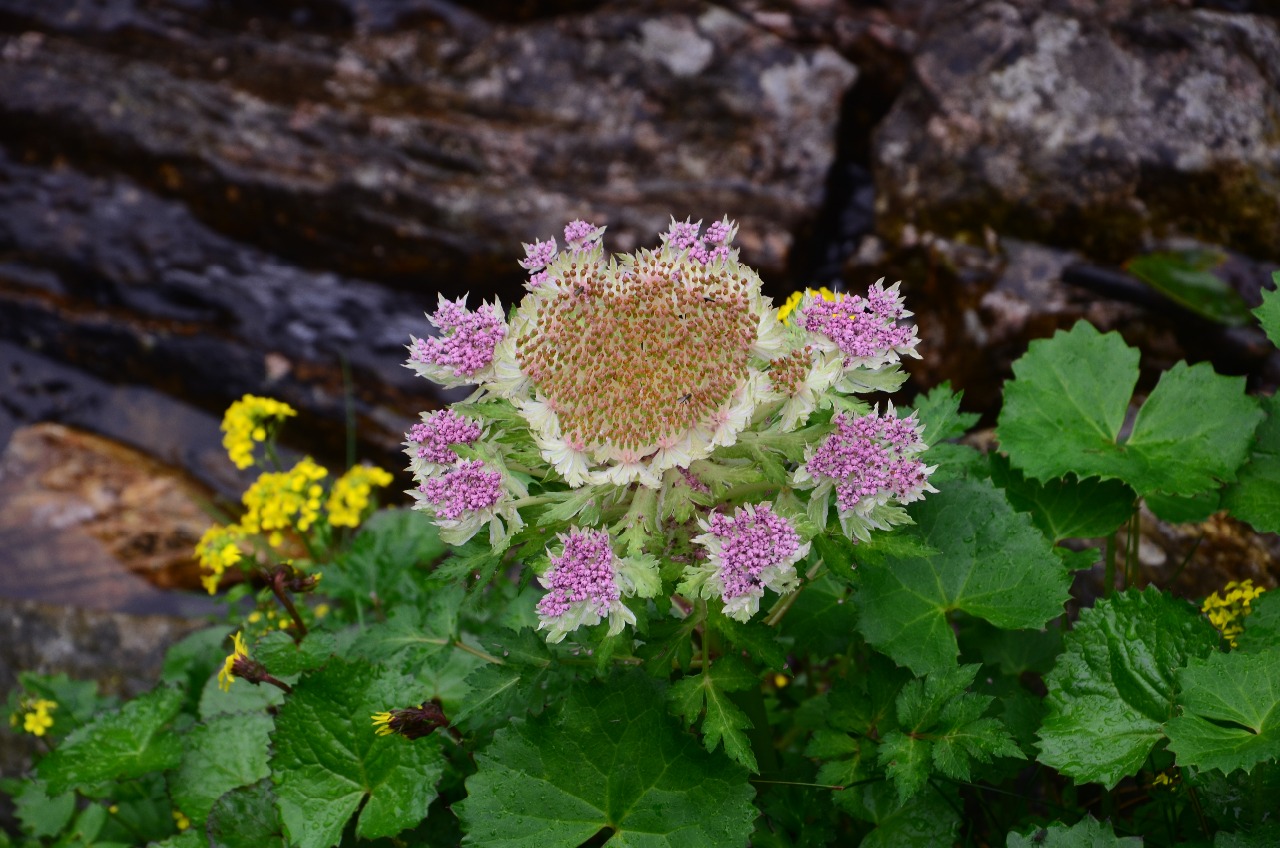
xmin=271 ymin=657 xmax=444 ymax=848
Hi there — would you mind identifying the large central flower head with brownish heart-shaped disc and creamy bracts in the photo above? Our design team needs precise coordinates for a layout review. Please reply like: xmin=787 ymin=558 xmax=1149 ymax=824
xmin=499 ymin=220 xmax=781 ymax=485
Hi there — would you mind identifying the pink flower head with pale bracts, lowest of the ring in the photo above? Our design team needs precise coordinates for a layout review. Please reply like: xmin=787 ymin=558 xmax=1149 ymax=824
xmin=538 ymin=528 xmax=635 ymax=642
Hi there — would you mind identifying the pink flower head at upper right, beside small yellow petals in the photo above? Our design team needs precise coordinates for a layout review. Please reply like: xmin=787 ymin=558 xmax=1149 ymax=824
xmin=800 ymin=283 xmax=919 ymax=368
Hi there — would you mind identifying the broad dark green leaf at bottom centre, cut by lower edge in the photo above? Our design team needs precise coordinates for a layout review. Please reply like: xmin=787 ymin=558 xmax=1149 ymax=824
xmin=453 ymin=674 xmax=756 ymax=848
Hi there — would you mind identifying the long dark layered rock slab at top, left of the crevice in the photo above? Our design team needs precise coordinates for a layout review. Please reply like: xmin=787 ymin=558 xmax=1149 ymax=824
xmin=0 ymin=0 xmax=855 ymax=293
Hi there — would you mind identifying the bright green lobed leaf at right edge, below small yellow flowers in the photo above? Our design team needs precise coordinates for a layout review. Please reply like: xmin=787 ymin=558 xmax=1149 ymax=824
xmin=1165 ymin=646 xmax=1280 ymax=774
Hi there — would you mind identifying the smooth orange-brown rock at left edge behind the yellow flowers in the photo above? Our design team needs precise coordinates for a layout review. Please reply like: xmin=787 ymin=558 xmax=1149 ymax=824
xmin=0 ymin=424 xmax=226 ymax=614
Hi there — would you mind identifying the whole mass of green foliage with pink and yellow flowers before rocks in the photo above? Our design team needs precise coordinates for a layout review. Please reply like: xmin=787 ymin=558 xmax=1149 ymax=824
xmin=0 ymin=233 xmax=1280 ymax=848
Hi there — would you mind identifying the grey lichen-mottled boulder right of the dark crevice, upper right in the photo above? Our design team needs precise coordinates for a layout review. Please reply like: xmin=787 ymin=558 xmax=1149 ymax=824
xmin=876 ymin=0 xmax=1280 ymax=261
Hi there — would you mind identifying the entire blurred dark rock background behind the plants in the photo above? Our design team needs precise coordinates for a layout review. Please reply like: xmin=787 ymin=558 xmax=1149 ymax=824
xmin=0 ymin=0 xmax=1280 ymax=722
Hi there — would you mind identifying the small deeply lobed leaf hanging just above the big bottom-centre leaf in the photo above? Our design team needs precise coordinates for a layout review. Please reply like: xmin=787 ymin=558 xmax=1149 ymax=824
xmin=667 ymin=656 xmax=760 ymax=772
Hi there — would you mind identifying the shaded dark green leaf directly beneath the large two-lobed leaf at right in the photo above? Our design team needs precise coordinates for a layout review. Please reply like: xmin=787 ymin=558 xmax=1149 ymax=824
xmin=991 ymin=453 xmax=1137 ymax=542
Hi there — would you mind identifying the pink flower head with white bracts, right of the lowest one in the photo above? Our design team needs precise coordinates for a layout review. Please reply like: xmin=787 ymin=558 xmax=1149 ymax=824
xmin=694 ymin=503 xmax=809 ymax=621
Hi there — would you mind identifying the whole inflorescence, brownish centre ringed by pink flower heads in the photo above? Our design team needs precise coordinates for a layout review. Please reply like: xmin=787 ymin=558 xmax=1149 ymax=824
xmin=406 ymin=219 xmax=934 ymax=640
